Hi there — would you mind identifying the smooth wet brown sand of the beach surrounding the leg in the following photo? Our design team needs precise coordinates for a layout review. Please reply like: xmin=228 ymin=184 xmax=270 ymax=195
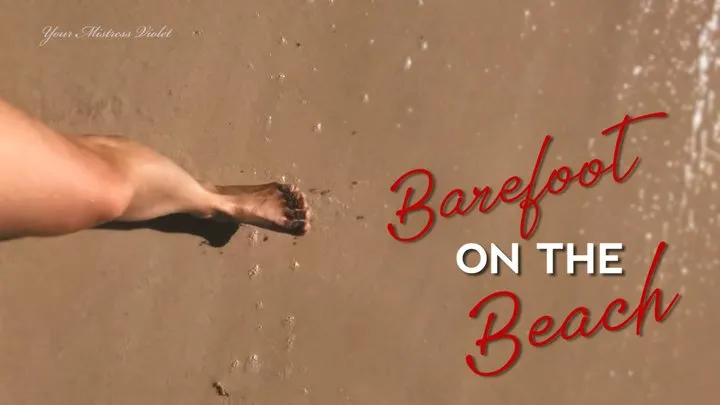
xmin=0 ymin=0 xmax=720 ymax=405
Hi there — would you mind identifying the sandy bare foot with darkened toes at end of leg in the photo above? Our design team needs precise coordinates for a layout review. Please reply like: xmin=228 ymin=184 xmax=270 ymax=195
xmin=215 ymin=183 xmax=311 ymax=236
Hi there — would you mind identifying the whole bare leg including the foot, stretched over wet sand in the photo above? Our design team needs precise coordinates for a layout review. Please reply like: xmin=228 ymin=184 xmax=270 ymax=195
xmin=0 ymin=96 xmax=310 ymax=239
